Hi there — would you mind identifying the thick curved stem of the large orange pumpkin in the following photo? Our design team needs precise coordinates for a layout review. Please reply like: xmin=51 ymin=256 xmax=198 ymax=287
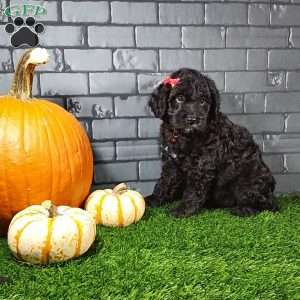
xmin=9 ymin=48 xmax=49 ymax=99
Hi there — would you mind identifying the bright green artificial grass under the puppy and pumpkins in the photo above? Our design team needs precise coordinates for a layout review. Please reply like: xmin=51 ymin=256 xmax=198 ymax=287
xmin=0 ymin=196 xmax=300 ymax=300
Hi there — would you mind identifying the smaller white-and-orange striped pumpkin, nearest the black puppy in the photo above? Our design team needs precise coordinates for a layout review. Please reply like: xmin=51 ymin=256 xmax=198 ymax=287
xmin=85 ymin=183 xmax=145 ymax=227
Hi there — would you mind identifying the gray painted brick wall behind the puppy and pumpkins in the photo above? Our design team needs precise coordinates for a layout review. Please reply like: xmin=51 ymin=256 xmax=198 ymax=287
xmin=0 ymin=0 xmax=300 ymax=194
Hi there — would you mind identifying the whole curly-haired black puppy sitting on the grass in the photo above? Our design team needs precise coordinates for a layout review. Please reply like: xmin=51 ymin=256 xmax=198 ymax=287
xmin=146 ymin=69 xmax=278 ymax=217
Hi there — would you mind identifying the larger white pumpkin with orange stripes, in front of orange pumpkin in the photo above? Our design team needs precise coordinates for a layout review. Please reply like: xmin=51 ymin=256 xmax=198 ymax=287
xmin=8 ymin=200 xmax=96 ymax=264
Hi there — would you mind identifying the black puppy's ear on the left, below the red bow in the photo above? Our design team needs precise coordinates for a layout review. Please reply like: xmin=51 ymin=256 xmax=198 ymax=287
xmin=148 ymin=84 xmax=170 ymax=119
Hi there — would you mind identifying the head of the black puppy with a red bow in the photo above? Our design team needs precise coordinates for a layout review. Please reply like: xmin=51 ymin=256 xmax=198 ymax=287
xmin=149 ymin=69 xmax=220 ymax=133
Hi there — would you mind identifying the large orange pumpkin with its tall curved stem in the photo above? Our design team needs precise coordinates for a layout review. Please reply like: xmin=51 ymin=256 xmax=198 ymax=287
xmin=0 ymin=48 xmax=93 ymax=235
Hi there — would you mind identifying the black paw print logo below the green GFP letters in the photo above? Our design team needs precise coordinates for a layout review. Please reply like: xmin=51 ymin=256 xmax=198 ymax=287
xmin=5 ymin=17 xmax=44 ymax=47
